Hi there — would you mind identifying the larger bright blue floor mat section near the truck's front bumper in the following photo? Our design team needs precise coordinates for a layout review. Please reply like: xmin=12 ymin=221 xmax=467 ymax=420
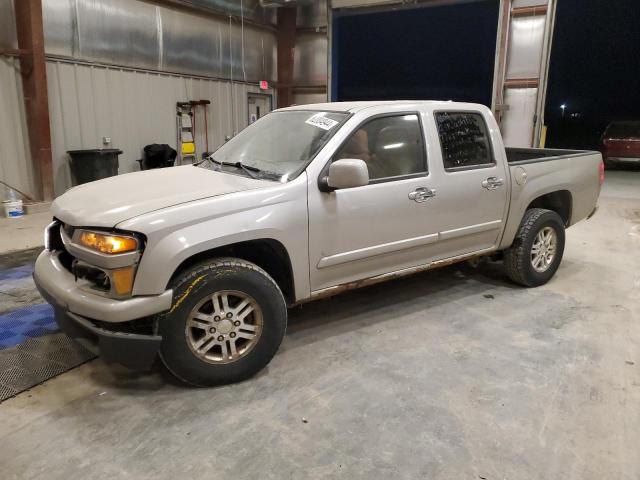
xmin=0 ymin=303 xmax=59 ymax=350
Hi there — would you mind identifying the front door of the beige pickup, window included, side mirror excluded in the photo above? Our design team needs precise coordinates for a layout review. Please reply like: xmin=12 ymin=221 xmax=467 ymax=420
xmin=308 ymin=112 xmax=438 ymax=292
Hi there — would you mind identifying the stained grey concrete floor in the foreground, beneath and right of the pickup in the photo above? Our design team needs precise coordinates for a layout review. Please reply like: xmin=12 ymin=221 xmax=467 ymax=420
xmin=0 ymin=171 xmax=640 ymax=480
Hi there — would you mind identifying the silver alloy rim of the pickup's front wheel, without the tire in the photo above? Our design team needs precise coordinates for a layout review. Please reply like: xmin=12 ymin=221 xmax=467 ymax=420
xmin=185 ymin=290 xmax=263 ymax=364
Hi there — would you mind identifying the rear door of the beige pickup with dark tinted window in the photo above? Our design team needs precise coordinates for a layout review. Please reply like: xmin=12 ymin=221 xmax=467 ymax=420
xmin=433 ymin=111 xmax=509 ymax=259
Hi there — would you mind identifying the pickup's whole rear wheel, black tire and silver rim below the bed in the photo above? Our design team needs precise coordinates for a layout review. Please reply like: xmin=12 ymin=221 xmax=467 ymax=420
xmin=504 ymin=208 xmax=565 ymax=287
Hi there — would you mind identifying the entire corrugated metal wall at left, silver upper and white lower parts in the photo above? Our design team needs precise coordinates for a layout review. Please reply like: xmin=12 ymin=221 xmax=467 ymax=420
xmin=0 ymin=0 xmax=276 ymax=199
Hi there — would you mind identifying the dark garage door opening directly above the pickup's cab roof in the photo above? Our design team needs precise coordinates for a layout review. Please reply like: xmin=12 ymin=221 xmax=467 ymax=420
xmin=332 ymin=0 xmax=500 ymax=106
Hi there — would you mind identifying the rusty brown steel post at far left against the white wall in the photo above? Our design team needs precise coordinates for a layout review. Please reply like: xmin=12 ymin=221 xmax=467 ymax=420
xmin=15 ymin=0 xmax=54 ymax=200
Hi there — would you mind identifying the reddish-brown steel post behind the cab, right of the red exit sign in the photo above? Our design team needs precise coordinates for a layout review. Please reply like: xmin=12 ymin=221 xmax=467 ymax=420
xmin=276 ymin=7 xmax=296 ymax=108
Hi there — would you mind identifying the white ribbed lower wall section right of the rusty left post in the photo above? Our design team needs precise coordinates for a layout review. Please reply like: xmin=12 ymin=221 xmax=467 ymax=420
xmin=47 ymin=61 xmax=271 ymax=195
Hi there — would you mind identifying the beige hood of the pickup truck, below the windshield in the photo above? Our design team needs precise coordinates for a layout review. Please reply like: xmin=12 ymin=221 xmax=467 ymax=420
xmin=51 ymin=165 xmax=273 ymax=228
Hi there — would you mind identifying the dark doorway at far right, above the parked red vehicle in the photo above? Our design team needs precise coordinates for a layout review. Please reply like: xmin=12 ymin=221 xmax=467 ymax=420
xmin=545 ymin=0 xmax=640 ymax=150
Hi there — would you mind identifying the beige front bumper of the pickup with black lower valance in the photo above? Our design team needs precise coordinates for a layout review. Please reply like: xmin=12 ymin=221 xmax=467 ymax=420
xmin=33 ymin=251 xmax=173 ymax=370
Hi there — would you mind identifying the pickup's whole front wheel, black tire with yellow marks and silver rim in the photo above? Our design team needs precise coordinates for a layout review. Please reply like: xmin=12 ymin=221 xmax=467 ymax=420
xmin=158 ymin=258 xmax=287 ymax=386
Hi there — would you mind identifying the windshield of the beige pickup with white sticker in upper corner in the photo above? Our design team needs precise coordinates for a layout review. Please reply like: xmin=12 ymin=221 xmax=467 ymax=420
xmin=200 ymin=110 xmax=349 ymax=182
